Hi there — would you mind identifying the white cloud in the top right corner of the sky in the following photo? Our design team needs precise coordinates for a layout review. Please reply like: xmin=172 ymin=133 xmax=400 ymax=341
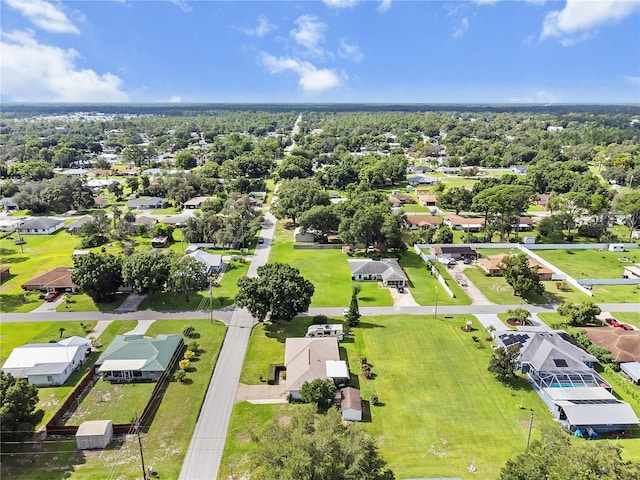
xmin=542 ymin=0 xmax=640 ymax=40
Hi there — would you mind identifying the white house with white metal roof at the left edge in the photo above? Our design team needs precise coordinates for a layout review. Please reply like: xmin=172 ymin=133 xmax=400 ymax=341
xmin=2 ymin=337 xmax=91 ymax=386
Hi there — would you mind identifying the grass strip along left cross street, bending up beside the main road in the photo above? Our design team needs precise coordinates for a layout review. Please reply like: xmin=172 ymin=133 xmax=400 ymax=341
xmin=138 ymin=260 xmax=249 ymax=311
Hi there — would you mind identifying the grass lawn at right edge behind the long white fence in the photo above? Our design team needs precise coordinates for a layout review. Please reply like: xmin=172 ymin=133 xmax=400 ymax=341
xmin=536 ymin=249 xmax=640 ymax=279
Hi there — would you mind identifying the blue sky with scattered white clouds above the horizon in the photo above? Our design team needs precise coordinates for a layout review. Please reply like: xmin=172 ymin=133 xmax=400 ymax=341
xmin=0 ymin=0 xmax=640 ymax=103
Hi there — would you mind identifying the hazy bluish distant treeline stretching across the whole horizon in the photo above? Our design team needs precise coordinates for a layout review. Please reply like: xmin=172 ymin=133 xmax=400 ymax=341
xmin=1 ymin=103 xmax=640 ymax=118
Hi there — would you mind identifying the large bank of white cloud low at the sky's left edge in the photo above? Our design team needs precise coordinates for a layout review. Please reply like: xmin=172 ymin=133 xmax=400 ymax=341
xmin=0 ymin=31 xmax=129 ymax=102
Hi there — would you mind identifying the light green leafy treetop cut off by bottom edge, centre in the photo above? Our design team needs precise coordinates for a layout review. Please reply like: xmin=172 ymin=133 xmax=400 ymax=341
xmin=250 ymin=406 xmax=395 ymax=480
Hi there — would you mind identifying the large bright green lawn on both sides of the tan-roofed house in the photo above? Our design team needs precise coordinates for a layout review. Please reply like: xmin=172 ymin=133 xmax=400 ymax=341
xmin=219 ymin=315 xmax=552 ymax=478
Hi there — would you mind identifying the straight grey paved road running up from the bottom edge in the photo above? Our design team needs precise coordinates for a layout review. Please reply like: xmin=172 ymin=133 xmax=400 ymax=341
xmin=180 ymin=213 xmax=276 ymax=480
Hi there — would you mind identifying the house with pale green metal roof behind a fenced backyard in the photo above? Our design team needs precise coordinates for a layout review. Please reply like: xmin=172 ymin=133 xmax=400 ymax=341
xmin=96 ymin=334 xmax=184 ymax=383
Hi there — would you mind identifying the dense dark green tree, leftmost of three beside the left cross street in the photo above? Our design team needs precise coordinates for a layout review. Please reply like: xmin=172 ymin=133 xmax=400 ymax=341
xmin=71 ymin=252 xmax=122 ymax=302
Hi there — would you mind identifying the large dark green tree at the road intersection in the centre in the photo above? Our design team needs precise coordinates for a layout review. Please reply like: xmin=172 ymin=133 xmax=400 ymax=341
xmin=236 ymin=263 xmax=315 ymax=321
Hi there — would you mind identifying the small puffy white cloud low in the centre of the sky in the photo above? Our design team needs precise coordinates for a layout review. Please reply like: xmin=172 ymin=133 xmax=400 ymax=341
xmin=261 ymin=53 xmax=346 ymax=94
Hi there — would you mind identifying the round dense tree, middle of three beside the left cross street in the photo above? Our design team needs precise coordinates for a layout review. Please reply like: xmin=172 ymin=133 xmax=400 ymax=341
xmin=122 ymin=252 xmax=171 ymax=294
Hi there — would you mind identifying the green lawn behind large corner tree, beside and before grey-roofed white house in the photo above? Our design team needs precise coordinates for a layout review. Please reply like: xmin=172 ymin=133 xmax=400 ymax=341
xmin=269 ymin=218 xmax=393 ymax=308
